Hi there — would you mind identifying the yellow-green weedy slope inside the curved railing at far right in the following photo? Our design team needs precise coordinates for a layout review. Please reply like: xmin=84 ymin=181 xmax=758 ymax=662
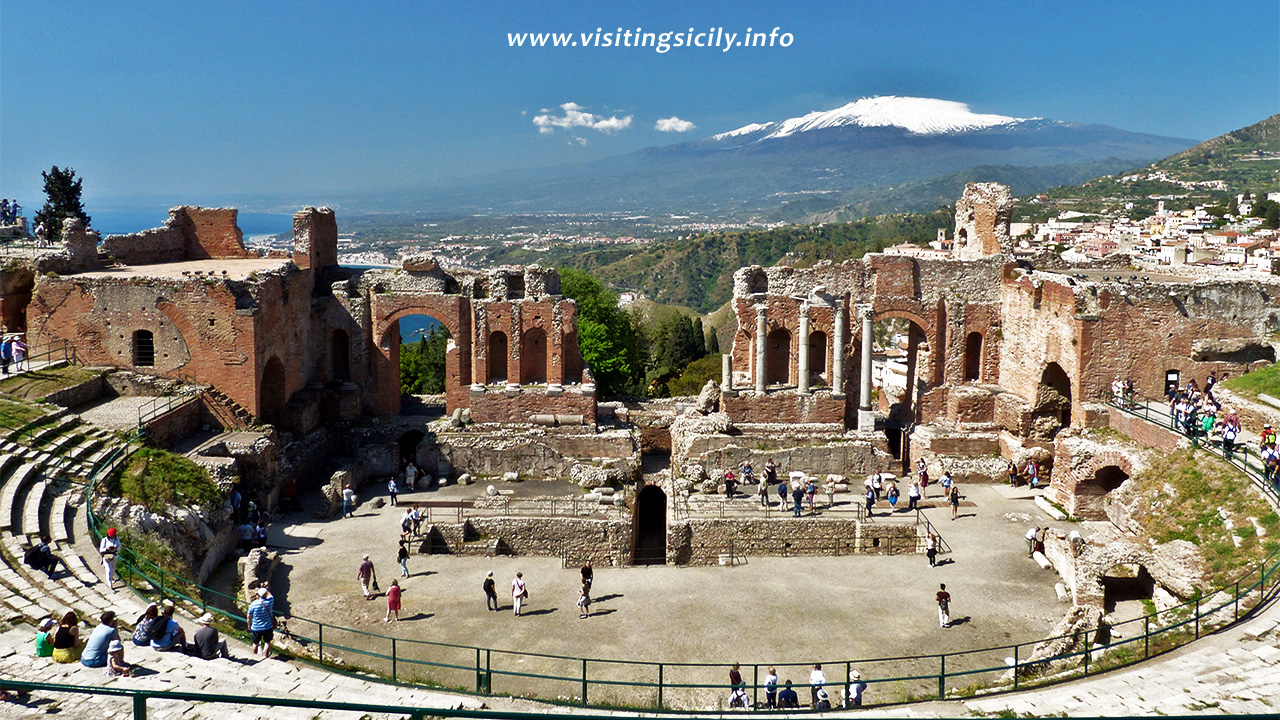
xmin=1134 ymin=450 xmax=1280 ymax=587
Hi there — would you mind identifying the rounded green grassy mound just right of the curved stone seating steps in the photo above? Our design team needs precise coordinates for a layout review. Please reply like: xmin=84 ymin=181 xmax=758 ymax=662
xmin=108 ymin=447 xmax=221 ymax=512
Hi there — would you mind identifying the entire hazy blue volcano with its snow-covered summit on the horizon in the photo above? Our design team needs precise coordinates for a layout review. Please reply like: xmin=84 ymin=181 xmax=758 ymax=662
xmin=394 ymin=96 xmax=1196 ymax=218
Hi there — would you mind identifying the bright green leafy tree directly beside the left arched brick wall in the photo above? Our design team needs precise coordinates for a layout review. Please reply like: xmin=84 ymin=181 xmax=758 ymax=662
xmin=559 ymin=268 xmax=644 ymax=396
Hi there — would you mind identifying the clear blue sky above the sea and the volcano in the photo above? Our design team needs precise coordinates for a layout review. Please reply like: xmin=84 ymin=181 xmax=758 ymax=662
xmin=0 ymin=0 xmax=1280 ymax=206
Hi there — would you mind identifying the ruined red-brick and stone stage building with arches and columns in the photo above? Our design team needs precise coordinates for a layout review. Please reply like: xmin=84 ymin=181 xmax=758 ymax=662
xmin=0 ymin=183 xmax=1280 ymax=584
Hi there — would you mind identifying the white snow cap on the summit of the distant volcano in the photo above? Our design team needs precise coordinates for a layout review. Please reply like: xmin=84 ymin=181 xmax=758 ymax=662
xmin=710 ymin=95 xmax=1039 ymax=140
